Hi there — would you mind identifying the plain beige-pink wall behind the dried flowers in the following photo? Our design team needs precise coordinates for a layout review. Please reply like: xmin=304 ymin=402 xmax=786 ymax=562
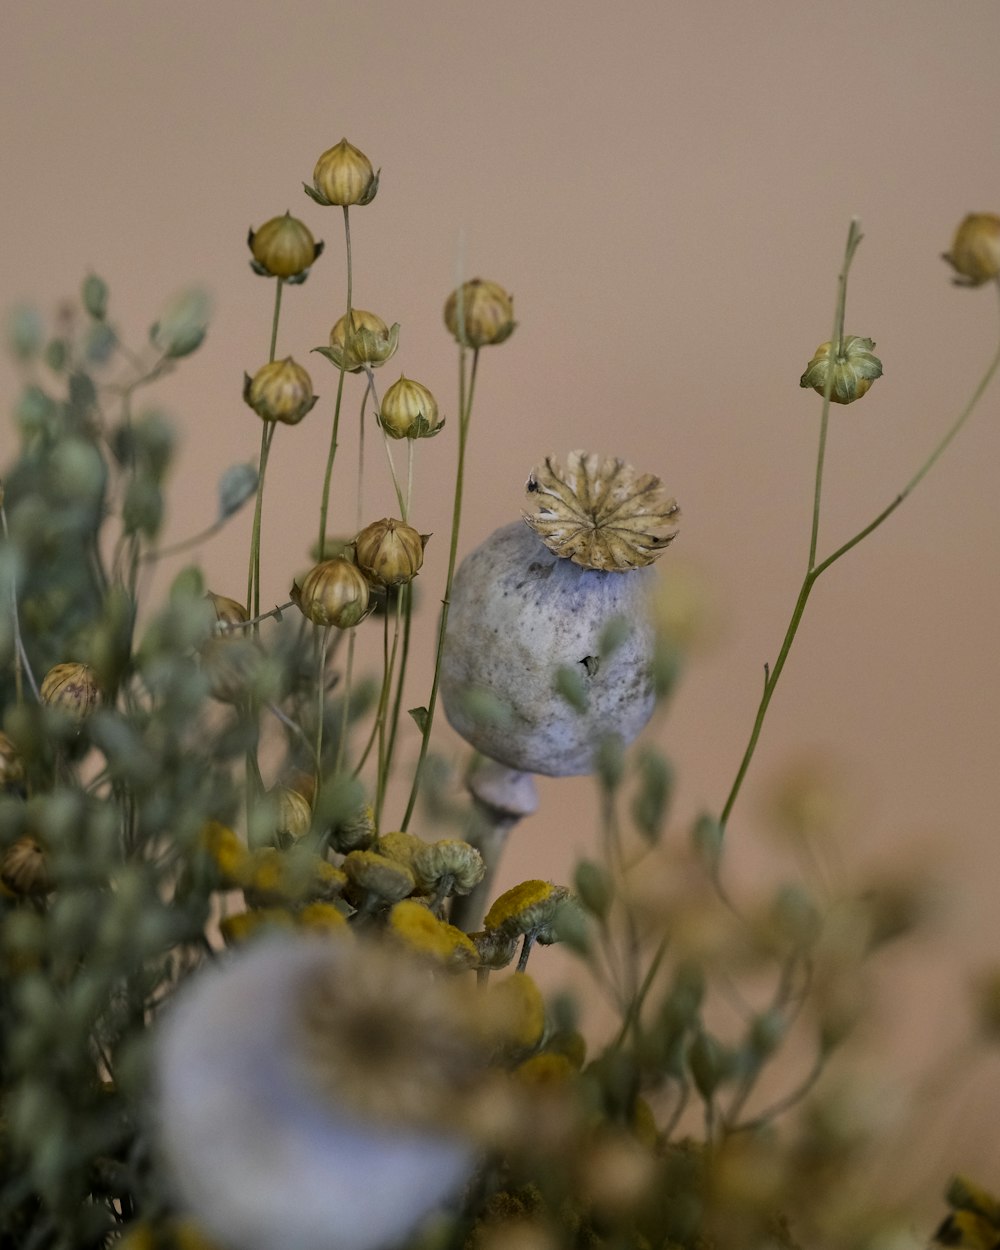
xmin=0 ymin=0 xmax=1000 ymax=1220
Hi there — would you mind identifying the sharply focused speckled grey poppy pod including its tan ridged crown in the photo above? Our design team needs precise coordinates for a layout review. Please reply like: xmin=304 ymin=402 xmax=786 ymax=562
xmin=440 ymin=453 xmax=678 ymax=776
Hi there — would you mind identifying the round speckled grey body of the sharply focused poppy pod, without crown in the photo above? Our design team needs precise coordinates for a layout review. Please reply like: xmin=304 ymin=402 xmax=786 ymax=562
xmin=441 ymin=521 xmax=655 ymax=776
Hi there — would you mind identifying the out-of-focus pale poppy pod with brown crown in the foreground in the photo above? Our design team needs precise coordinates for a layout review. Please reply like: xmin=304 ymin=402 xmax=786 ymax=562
xmin=156 ymin=939 xmax=476 ymax=1250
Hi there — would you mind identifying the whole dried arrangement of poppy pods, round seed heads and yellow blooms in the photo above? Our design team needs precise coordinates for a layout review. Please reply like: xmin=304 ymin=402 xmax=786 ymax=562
xmin=0 ymin=140 xmax=1000 ymax=1250
